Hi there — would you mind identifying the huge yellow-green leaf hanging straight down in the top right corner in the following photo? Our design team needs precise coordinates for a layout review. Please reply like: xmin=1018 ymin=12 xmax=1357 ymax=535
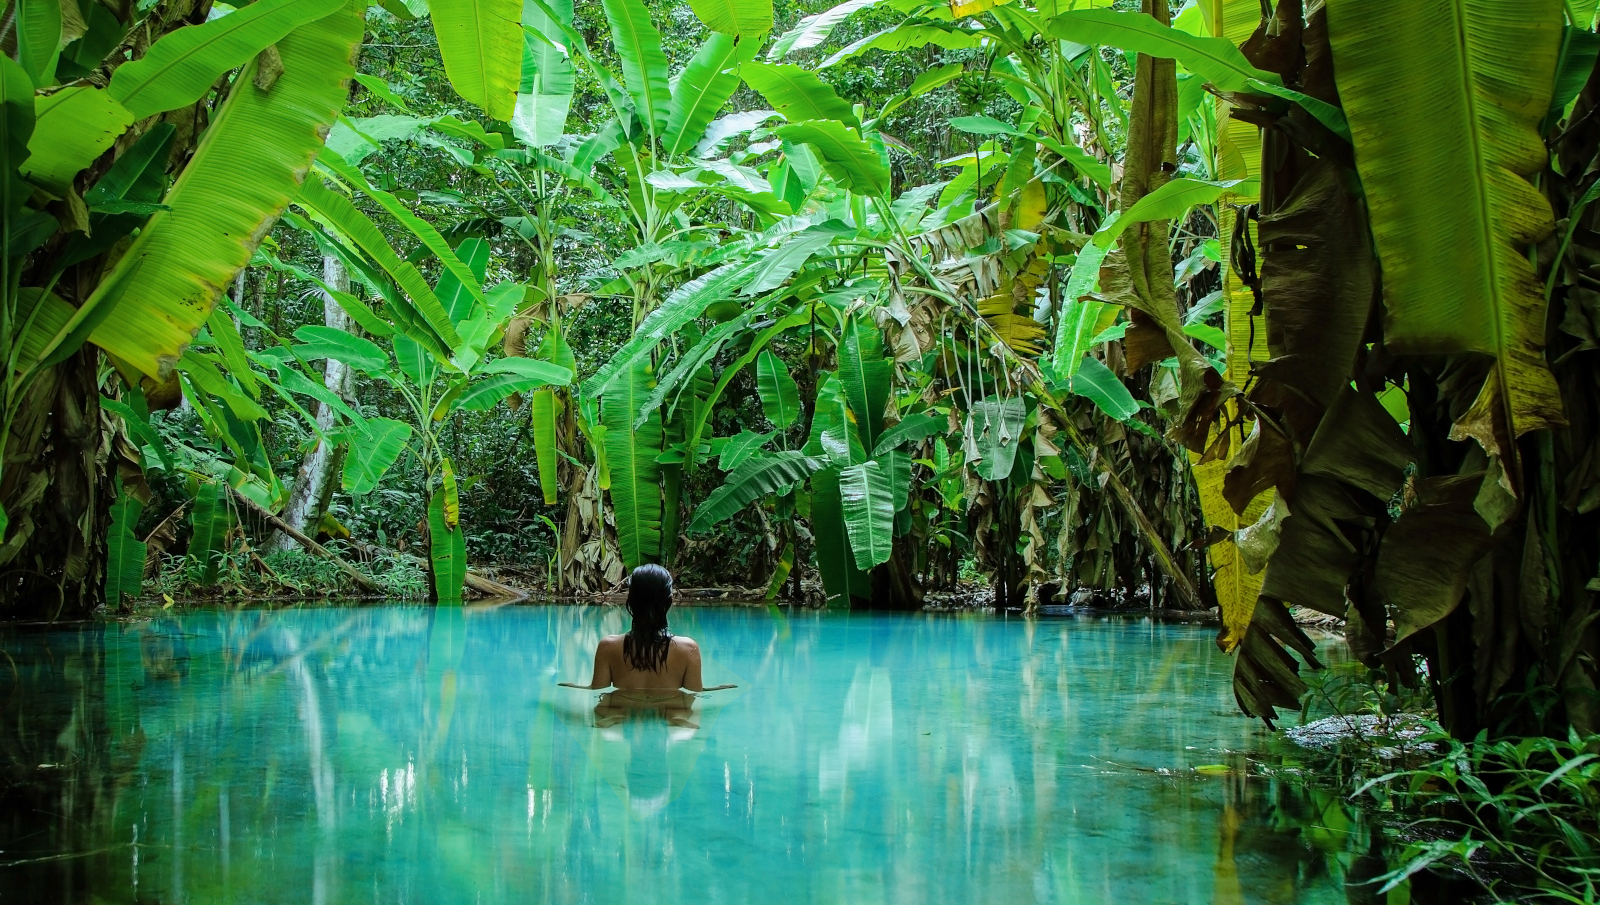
xmin=1328 ymin=0 xmax=1565 ymax=454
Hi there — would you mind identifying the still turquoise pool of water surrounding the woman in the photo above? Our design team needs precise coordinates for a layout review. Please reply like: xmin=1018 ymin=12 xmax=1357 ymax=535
xmin=0 ymin=606 xmax=1381 ymax=905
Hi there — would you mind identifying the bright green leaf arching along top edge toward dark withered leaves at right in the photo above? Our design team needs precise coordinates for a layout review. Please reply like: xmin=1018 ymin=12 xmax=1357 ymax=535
xmin=1045 ymin=10 xmax=1280 ymax=91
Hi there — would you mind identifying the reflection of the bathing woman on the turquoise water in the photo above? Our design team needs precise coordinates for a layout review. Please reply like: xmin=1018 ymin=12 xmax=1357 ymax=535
xmin=594 ymin=691 xmax=699 ymax=817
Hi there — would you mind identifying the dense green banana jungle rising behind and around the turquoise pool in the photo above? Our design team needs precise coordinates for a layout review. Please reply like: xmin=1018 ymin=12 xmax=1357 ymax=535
xmin=0 ymin=0 xmax=1600 ymax=889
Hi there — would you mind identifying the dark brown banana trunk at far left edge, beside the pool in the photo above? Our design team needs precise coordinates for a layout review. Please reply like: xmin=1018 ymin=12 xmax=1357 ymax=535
xmin=0 ymin=345 xmax=114 ymax=619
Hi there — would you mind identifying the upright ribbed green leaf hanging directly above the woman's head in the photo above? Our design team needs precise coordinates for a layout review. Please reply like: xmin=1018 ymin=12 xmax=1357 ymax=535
xmin=600 ymin=358 xmax=662 ymax=569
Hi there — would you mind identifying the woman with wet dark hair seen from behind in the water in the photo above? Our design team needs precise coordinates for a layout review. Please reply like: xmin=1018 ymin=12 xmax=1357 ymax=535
xmin=560 ymin=563 xmax=734 ymax=692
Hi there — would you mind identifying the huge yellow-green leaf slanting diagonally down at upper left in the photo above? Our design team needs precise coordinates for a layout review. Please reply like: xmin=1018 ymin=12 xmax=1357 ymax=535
xmin=86 ymin=0 xmax=366 ymax=377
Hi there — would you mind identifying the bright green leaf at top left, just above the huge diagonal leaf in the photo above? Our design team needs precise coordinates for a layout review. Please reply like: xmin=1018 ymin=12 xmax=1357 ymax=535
xmin=107 ymin=0 xmax=349 ymax=120
